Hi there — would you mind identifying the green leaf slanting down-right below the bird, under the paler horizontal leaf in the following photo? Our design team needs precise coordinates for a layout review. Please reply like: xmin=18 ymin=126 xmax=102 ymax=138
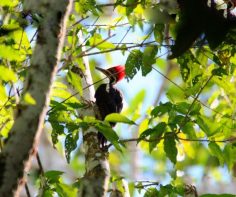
xmin=95 ymin=124 xmax=122 ymax=152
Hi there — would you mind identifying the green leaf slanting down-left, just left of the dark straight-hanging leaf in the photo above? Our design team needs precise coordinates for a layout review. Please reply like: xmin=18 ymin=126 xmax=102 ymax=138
xmin=149 ymin=122 xmax=167 ymax=153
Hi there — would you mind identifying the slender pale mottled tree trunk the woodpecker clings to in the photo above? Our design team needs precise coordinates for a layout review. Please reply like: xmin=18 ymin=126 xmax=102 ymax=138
xmin=79 ymin=32 xmax=110 ymax=197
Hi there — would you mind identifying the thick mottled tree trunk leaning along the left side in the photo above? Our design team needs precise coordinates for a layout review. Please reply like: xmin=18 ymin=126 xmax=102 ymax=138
xmin=0 ymin=0 xmax=72 ymax=196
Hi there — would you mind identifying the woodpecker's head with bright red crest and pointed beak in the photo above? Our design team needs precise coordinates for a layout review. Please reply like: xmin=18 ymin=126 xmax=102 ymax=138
xmin=96 ymin=65 xmax=125 ymax=84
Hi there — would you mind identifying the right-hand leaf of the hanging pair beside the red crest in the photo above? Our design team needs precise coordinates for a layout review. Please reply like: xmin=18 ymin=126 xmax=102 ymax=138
xmin=141 ymin=45 xmax=158 ymax=76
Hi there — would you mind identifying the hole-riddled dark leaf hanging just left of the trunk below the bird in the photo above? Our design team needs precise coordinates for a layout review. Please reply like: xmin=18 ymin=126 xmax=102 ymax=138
xmin=65 ymin=132 xmax=79 ymax=163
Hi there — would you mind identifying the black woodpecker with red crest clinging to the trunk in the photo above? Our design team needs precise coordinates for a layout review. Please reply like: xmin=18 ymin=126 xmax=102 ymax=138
xmin=95 ymin=65 xmax=125 ymax=147
